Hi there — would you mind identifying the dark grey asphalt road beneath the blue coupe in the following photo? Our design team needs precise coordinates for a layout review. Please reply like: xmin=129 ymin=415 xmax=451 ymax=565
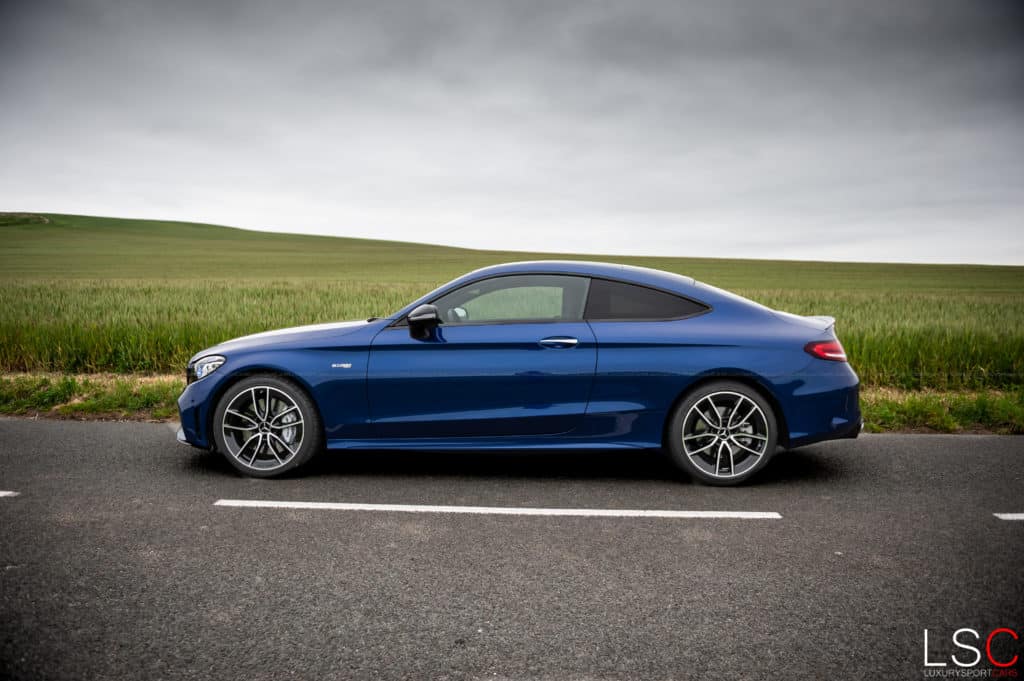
xmin=0 ymin=419 xmax=1024 ymax=680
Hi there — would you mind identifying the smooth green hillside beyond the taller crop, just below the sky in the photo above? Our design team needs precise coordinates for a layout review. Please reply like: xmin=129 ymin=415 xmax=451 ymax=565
xmin=0 ymin=213 xmax=1024 ymax=294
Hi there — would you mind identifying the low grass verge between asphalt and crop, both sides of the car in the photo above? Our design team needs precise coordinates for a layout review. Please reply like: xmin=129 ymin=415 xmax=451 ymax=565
xmin=0 ymin=374 xmax=1024 ymax=434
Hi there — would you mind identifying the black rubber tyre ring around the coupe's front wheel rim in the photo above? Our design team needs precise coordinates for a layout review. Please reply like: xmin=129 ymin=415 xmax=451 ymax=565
xmin=212 ymin=374 xmax=324 ymax=477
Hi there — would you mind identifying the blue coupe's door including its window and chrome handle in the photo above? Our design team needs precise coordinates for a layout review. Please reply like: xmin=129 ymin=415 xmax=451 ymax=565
xmin=367 ymin=274 xmax=597 ymax=437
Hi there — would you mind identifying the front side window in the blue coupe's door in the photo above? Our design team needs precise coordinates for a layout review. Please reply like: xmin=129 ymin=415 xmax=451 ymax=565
xmin=434 ymin=274 xmax=590 ymax=324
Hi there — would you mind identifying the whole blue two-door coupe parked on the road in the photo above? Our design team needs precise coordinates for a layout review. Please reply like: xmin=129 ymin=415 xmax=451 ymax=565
xmin=178 ymin=261 xmax=862 ymax=484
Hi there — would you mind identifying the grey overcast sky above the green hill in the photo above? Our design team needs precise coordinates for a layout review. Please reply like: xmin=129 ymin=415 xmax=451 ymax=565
xmin=0 ymin=0 xmax=1024 ymax=264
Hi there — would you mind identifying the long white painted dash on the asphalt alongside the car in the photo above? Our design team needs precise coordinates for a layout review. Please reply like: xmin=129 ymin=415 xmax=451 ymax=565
xmin=214 ymin=499 xmax=782 ymax=520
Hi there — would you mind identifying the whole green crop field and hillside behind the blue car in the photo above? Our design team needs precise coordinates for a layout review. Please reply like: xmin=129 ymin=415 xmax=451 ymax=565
xmin=0 ymin=214 xmax=1024 ymax=391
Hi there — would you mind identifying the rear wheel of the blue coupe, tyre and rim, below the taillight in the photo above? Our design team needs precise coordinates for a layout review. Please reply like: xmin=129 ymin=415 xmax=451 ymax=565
xmin=666 ymin=381 xmax=778 ymax=485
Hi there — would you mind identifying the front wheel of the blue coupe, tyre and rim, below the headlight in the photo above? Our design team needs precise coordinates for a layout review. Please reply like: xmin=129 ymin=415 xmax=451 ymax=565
xmin=213 ymin=375 xmax=324 ymax=477
